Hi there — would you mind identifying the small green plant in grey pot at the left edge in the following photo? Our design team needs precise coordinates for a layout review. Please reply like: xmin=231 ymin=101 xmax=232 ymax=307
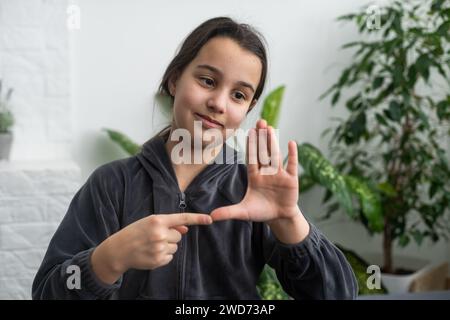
xmin=0 ymin=79 xmax=14 ymax=160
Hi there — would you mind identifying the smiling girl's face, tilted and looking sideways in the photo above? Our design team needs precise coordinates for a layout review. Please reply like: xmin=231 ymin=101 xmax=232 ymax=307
xmin=169 ymin=37 xmax=262 ymax=145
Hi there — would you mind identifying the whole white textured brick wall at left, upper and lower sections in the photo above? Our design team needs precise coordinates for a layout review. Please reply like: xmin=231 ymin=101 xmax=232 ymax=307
xmin=0 ymin=0 xmax=80 ymax=299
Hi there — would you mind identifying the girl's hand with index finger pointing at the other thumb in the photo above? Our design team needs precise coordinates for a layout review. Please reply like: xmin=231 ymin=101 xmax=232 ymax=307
xmin=91 ymin=213 xmax=212 ymax=284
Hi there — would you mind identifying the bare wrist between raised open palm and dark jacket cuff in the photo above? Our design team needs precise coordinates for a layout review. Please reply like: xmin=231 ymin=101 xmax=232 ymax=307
xmin=267 ymin=206 xmax=310 ymax=244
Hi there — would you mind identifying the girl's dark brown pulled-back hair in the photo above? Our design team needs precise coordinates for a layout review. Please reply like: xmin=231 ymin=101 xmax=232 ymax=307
xmin=158 ymin=17 xmax=267 ymax=135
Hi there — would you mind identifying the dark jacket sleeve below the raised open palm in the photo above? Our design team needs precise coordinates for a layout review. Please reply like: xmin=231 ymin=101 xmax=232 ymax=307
xmin=262 ymin=223 xmax=358 ymax=300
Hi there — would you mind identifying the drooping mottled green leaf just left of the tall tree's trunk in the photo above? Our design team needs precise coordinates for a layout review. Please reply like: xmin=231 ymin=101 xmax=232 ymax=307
xmin=344 ymin=175 xmax=384 ymax=232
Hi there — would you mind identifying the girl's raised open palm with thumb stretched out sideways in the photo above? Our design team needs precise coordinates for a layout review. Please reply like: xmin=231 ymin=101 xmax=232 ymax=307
xmin=211 ymin=120 xmax=300 ymax=222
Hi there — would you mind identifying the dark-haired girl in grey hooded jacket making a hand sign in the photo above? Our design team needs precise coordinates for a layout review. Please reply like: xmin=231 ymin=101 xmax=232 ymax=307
xmin=32 ymin=17 xmax=357 ymax=299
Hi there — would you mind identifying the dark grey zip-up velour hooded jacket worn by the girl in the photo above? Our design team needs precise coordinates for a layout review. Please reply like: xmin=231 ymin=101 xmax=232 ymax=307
xmin=32 ymin=136 xmax=357 ymax=299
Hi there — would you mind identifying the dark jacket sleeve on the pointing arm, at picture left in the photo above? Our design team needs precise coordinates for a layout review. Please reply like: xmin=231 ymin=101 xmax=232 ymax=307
xmin=32 ymin=165 xmax=123 ymax=299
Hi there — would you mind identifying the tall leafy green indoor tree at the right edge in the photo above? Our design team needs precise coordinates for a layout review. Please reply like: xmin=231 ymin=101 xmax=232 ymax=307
xmin=323 ymin=0 xmax=450 ymax=292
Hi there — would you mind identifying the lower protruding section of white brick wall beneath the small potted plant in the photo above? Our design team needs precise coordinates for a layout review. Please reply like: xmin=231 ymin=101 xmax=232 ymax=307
xmin=0 ymin=161 xmax=80 ymax=299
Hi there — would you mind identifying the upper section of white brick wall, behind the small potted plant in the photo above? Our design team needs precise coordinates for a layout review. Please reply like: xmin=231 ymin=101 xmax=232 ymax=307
xmin=0 ymin=0 xmax=72 ymax=160
